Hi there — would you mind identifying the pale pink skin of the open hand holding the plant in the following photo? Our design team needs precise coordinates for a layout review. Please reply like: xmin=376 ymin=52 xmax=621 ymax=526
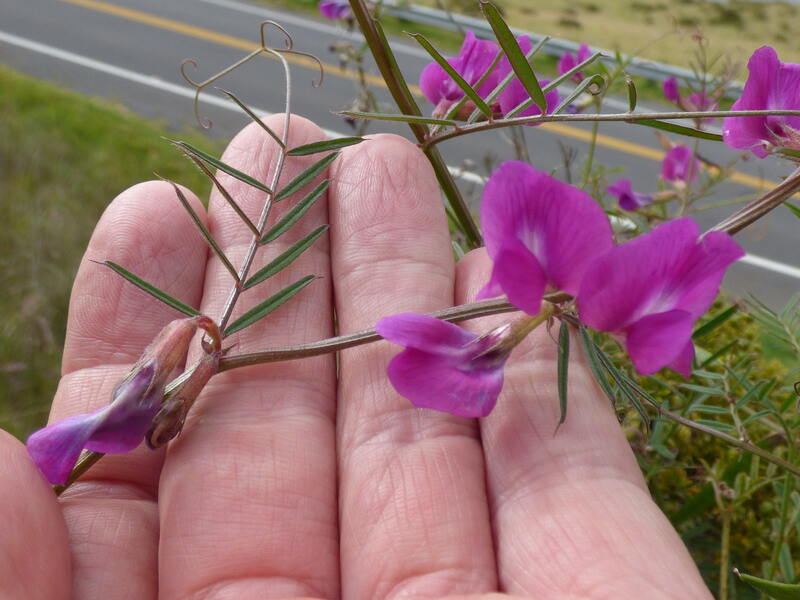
xmin=0 ymin=117 xmax=711 ymax=600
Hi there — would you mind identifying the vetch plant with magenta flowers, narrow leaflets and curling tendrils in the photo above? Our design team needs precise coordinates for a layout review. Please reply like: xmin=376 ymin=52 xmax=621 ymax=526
xmin=14 ymin=0 xmax=800 ymax=595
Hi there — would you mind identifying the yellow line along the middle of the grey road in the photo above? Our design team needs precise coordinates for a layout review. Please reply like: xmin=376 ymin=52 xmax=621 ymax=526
xmin=60 ymin=0 xmax=777 ymax=189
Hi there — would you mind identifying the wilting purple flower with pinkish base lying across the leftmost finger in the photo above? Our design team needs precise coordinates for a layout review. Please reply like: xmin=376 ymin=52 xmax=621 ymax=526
xmin=27 ymin=316 xmax=219 ymax=484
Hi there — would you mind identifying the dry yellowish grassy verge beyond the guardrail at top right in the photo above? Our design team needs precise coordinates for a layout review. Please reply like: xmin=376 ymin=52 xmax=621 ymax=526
xmin=406 ymin=0 xmax=800 ymax=68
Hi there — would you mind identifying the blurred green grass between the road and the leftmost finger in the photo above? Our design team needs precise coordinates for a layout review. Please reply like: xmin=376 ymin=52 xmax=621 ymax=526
xmin=0 ymin=67 xmax=217 ymax=437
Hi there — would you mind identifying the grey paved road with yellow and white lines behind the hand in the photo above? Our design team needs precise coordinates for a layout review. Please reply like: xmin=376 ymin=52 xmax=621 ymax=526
xmin=0 ymin=0 xmax=800 ymax=306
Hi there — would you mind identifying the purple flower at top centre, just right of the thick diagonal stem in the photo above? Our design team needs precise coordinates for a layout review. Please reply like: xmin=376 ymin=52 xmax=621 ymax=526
xmin=419 ymin=31 xmax=499 ymax=114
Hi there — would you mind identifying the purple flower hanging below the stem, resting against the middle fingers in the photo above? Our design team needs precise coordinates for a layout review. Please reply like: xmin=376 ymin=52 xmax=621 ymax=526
xmin=375 ymin=313 xmax=509 ymax=417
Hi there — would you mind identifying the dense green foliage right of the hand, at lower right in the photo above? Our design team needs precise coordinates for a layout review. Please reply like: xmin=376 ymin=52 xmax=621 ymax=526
xmin=600 ymin=299 xmax=800 ymax=598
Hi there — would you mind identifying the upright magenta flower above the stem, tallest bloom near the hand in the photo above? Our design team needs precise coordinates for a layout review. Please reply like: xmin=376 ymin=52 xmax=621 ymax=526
xmin=478 ymin=161 xmax=613 ymax=315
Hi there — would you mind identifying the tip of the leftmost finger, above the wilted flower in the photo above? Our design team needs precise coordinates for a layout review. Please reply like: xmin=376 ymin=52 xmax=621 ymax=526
xmin=62 ymin=181 xmax=207 ymax=374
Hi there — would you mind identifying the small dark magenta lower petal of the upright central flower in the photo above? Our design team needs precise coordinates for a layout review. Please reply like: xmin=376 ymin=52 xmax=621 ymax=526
xmin=492 ymin=239 xmax=547 ymax=315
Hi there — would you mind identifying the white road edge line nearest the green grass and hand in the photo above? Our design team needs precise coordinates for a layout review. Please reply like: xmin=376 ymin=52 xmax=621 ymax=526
xmin=0 ymin=27 xmax=800 ymax=279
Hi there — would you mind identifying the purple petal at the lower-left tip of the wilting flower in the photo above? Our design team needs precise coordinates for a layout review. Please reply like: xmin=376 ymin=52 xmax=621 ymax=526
xmin=26 ymin=407 xmax=108 ymax=485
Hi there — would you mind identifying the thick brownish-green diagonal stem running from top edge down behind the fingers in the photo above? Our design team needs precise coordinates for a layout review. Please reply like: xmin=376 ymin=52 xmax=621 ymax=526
xmin=350 ymin=0 xmax=483 ymax=248
